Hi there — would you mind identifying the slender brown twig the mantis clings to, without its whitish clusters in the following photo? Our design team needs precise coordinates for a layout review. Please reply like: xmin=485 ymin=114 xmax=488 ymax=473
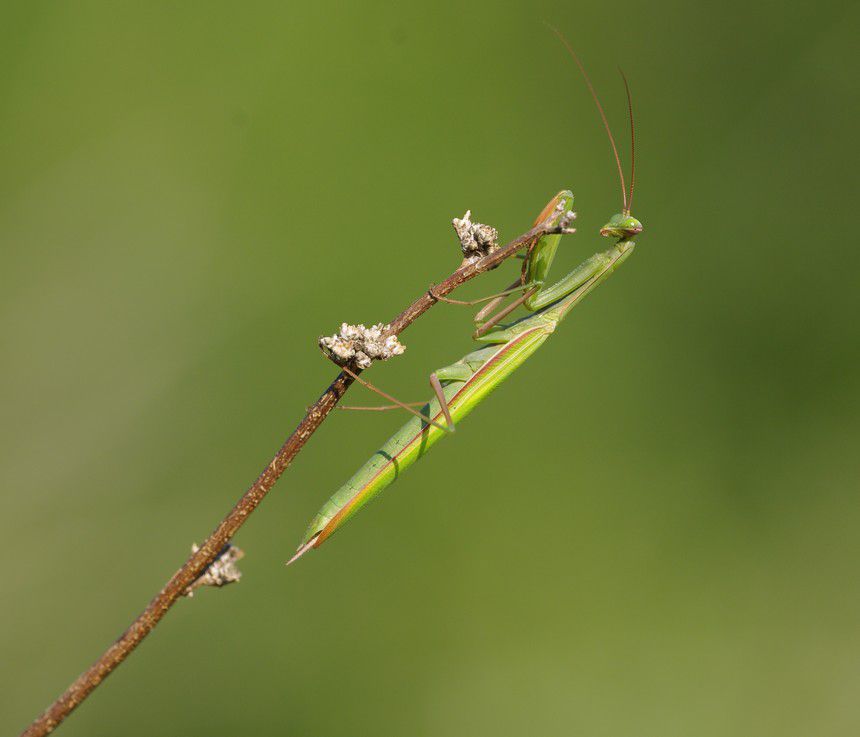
xmin=21 ymin=214 xmax=566 ymax=737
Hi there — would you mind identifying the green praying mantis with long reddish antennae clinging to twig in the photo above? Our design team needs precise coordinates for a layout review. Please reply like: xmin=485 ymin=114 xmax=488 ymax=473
xmin=288 ymin=34 xmax=642 ymax=565
